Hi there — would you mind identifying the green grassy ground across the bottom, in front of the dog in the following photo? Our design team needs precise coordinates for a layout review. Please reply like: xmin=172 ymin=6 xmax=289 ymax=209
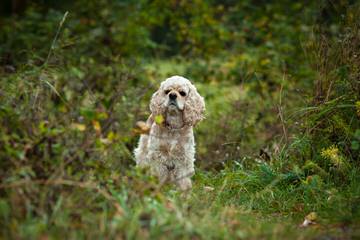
xmin=0 ymin=163 xmax=360 ymax=239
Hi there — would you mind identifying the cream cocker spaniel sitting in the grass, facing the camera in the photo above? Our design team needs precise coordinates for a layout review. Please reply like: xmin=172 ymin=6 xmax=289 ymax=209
xmin=134 ymin=76 xmax=205 ymax=190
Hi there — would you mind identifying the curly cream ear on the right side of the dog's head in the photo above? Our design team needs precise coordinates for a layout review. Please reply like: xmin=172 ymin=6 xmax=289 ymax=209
xmin=184 ymin=84 xmax=205 ymax=126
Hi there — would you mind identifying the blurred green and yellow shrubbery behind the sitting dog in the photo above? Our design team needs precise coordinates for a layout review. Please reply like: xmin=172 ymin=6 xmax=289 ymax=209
xmin=0 ymin=0 xmax=360 ymax=238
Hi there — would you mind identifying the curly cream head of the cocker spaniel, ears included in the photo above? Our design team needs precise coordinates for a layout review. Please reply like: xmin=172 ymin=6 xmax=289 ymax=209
xmin=150 ymin=76 xmax=205 ymax=128
